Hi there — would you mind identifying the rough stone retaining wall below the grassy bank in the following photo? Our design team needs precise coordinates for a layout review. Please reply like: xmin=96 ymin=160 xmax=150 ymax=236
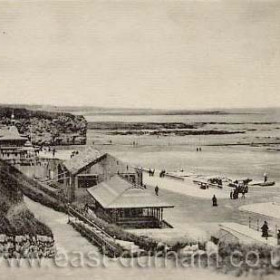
xmin=0 ymin=234 xmax=55 ymax=258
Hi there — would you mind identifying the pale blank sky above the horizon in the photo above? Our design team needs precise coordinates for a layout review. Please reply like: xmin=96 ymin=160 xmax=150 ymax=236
xmin=0 ymin=0 xmax=280 ymax=109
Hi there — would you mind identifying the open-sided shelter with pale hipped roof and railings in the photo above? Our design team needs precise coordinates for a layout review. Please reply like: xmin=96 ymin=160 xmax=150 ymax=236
xmin=87 ymin=175 xmax=174 ymax=228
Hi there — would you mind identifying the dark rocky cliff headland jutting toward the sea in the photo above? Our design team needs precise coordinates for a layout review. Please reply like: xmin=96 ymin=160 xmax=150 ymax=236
xmin=0 ymin=106 xmax=87 ymax=145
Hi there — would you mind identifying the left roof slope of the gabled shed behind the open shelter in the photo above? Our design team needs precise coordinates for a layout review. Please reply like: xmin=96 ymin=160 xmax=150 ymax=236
xmin=63 ymin=147 xmax=106 ymax=174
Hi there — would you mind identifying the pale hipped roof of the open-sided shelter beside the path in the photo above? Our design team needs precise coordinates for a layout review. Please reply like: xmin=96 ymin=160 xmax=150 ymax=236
xmin=87 ymin=175 xmax=173 ymax=209
